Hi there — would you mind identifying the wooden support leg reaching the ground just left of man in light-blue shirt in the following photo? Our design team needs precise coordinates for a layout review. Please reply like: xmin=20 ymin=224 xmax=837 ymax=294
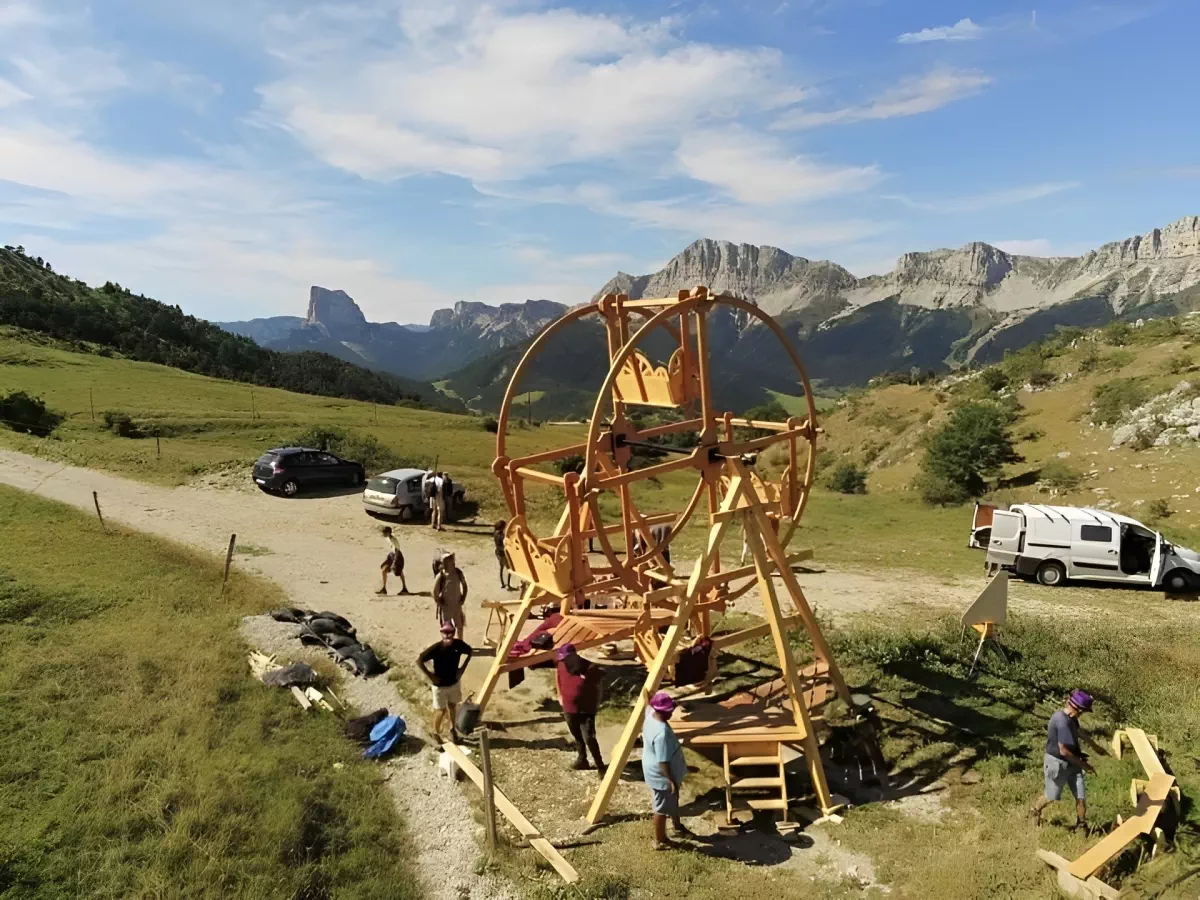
xmin=588 ymin=475 xmax=746 ymax=824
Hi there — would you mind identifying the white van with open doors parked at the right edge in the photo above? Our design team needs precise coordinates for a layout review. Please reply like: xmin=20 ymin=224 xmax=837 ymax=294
xmin=970 ymin=503 xmax=1200 ymax=594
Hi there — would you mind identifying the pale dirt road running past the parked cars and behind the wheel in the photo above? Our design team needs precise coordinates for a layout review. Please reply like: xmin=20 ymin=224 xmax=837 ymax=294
xmin=0 ymin=451 xmax=1132 ymax=676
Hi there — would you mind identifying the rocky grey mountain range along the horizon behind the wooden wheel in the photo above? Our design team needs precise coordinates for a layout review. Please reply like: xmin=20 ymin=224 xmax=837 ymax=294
xmin=218 ymin=216 xmax=1200 ymax=416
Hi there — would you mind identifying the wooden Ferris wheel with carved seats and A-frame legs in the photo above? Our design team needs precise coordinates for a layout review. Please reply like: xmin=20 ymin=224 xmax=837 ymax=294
xmin=478 ymin=287 xmax=852 ymax=823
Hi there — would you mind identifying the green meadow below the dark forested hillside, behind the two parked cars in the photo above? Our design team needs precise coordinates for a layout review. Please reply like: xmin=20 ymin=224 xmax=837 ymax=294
xmin=0 ymin=332 xmax=572 ymax=515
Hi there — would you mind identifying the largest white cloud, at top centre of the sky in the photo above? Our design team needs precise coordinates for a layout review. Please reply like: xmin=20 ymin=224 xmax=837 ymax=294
xmin=260 ymin=4 xmax=803 ymax=180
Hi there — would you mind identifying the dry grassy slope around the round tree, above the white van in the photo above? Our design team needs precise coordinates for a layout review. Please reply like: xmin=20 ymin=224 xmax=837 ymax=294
xmin=822 ymin=320 xmax=1200 ymax=547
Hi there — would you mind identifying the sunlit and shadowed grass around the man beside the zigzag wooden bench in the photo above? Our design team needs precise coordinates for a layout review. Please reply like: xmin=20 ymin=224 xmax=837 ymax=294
xmin=834 ymin=618 xmax=1200 ymax=900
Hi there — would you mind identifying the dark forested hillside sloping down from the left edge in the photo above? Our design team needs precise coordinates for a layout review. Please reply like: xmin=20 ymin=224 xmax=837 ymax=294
xmin=0 ymin=246 xmax=455 ymax=406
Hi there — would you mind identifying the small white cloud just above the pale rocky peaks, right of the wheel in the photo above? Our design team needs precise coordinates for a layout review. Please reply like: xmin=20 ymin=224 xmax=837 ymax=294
xmin=676 ymin=128 xmax=882 ymax=205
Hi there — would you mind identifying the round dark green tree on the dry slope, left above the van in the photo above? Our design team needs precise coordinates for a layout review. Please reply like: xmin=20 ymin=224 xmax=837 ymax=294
xmin=918 ymin=403 xmax=1021 ymax=504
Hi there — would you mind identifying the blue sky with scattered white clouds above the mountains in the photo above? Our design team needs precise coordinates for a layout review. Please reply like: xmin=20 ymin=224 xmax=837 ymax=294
xmin=0 ymin=0 xmax=1200 ymax=322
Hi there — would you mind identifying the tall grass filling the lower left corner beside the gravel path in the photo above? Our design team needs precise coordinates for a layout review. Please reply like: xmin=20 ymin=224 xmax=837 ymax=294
xmin=0 ymin=487 xmax=419 ymax=900
